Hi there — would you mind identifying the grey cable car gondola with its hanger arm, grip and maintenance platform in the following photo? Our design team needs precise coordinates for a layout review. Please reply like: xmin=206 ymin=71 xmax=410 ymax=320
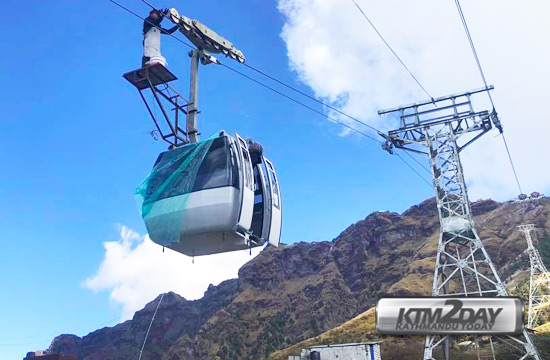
xmin=123 ymin=9 xmax=282 ymax=256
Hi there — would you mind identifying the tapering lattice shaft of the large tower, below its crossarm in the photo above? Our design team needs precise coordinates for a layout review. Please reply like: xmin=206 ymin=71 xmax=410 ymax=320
xmin=424 ymin=129 xmax=541 ymax=360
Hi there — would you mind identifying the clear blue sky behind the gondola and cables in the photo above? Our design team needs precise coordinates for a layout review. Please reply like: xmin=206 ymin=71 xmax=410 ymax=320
xmin=0 ymin=0 xmax=546 ymax=359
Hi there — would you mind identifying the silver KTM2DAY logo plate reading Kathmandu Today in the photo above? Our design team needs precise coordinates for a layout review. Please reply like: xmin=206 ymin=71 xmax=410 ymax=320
xmin=376 ymin=297 xmax=523 ymax=335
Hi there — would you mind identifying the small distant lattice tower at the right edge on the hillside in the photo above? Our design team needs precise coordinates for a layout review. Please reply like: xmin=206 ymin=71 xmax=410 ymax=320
xmin=518 ymin=224 xmax=550 ymax=329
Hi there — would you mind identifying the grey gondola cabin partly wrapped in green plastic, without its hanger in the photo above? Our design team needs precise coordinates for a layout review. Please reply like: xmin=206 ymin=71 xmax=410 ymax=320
xmin=136 ymin=131 xmax=282 ymax=256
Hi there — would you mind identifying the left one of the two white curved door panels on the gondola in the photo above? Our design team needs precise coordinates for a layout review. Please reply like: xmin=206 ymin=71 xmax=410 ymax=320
xmin=235 ymin=133 xmax=254 ymax=232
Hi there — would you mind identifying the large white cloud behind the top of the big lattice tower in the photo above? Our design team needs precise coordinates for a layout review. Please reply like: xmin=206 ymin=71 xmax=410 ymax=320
xmin=279 ymin=0 xmax=550 ymax=200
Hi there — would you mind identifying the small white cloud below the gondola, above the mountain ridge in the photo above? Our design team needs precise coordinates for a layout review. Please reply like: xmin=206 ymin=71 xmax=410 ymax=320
xmin=83 ymin=226 xmax=262 ymax=320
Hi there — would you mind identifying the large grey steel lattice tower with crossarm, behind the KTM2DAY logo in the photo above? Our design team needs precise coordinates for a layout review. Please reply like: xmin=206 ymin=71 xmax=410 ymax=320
xmin=378 ymin=86 xmax=541 ymax=360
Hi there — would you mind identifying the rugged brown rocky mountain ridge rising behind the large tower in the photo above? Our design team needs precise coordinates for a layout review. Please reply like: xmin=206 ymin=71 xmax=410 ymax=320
xmin=42 ymin=198 xmax=550 ymax=360
